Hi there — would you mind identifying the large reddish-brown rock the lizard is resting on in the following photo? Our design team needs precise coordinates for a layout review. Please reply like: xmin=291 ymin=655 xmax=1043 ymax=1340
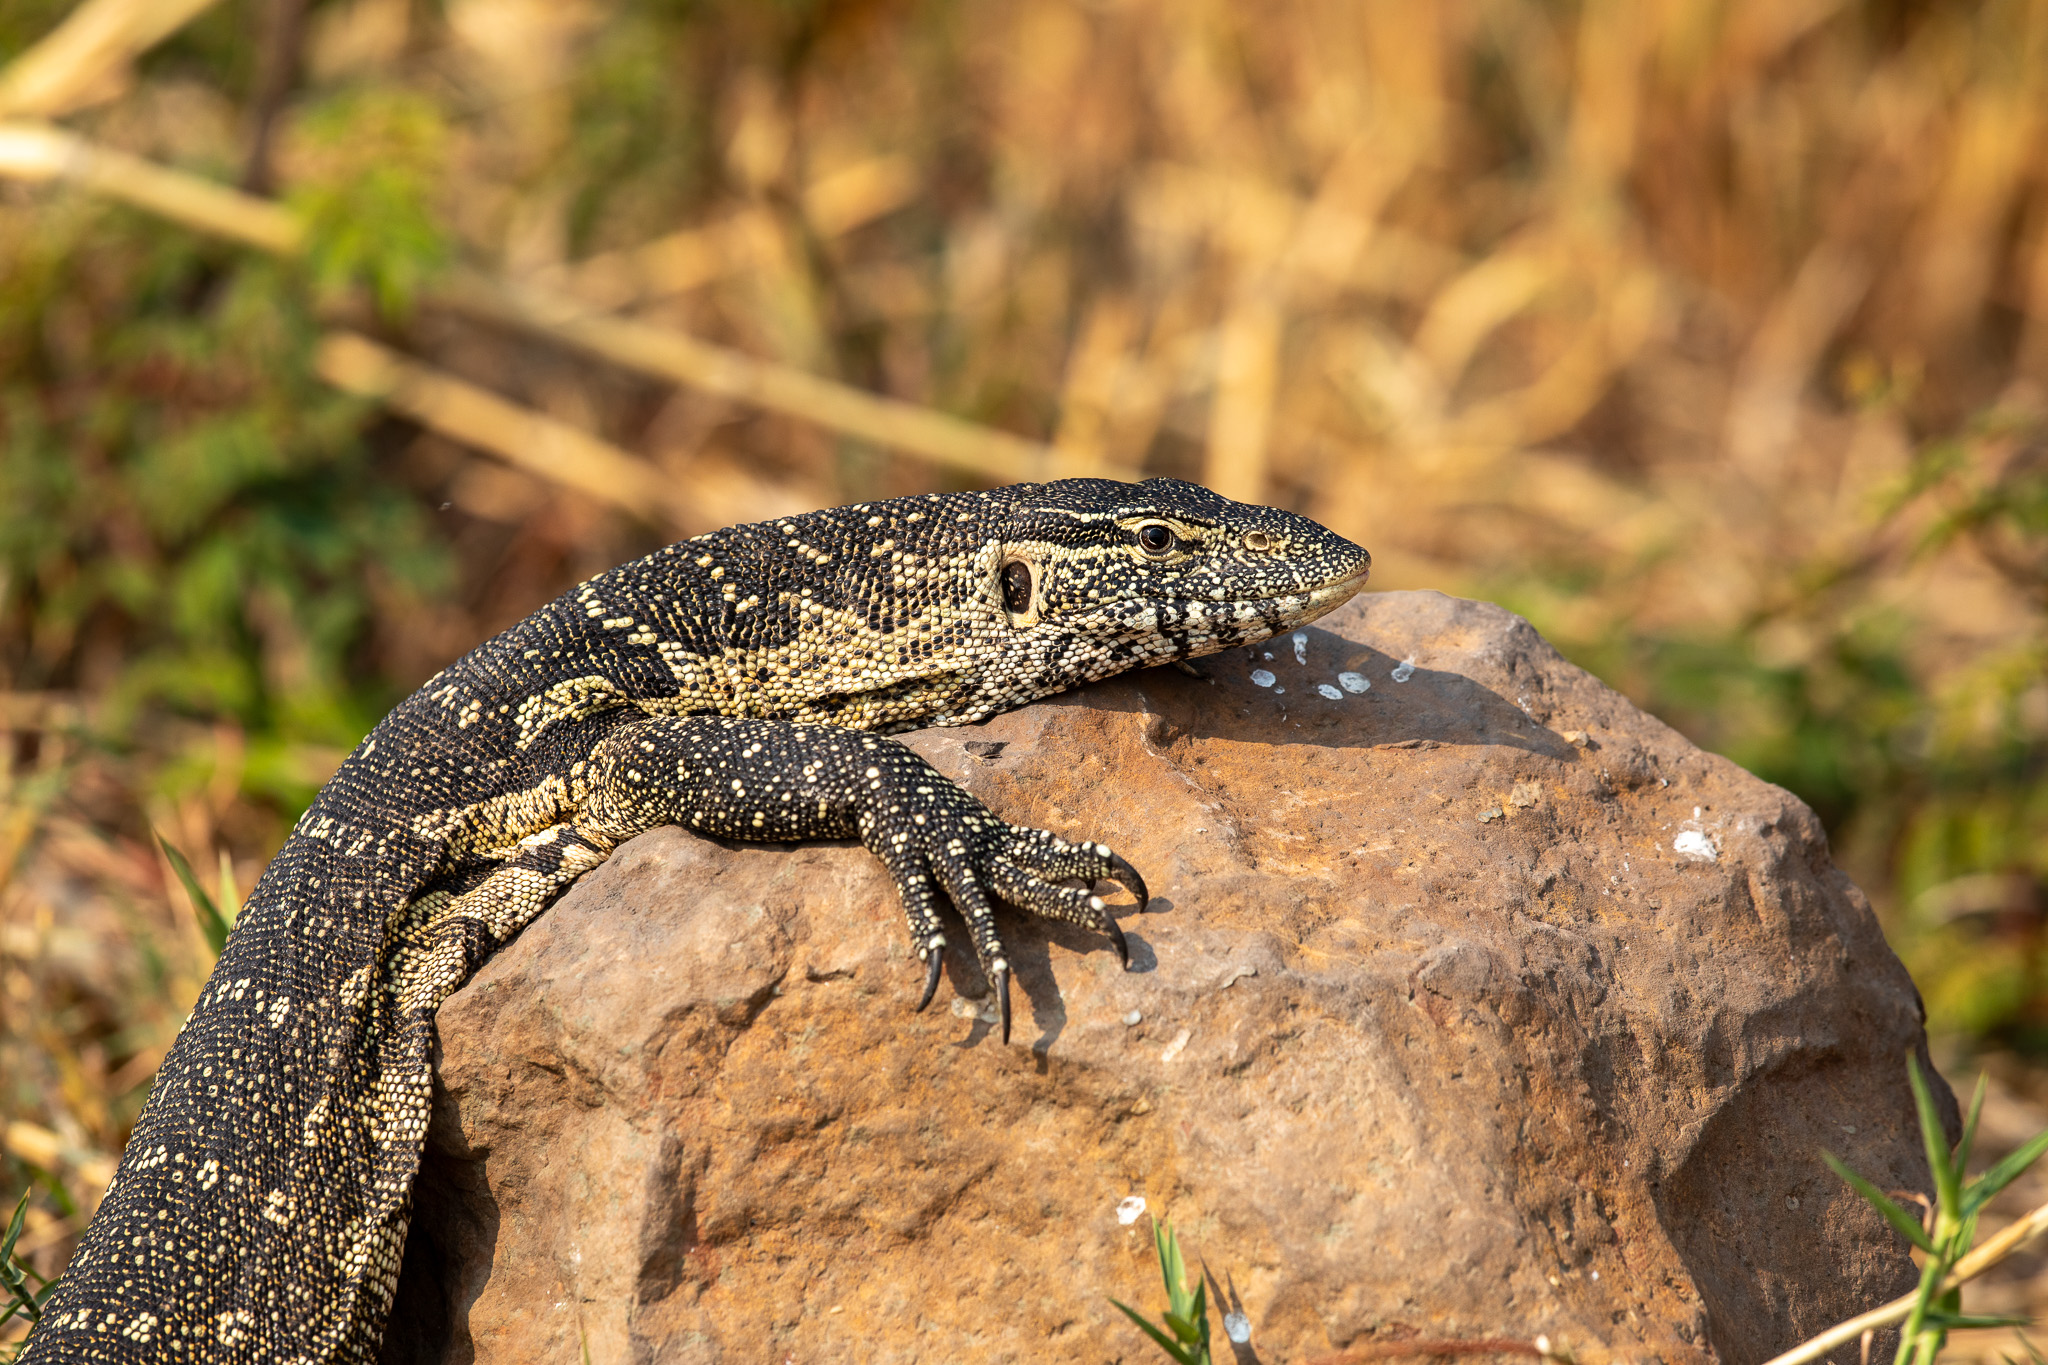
xmin=389 ymin=593 xmax=1952 ymax=1365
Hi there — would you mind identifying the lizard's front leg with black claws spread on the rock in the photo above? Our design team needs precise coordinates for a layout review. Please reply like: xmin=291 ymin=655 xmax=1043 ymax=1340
xmin=578 ymin=716 xmax=1147 ymax=1042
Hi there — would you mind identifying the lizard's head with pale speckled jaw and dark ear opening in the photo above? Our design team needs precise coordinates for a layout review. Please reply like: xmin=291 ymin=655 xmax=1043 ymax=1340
xmin=989 ymin=479 xmax=1372 ymax=686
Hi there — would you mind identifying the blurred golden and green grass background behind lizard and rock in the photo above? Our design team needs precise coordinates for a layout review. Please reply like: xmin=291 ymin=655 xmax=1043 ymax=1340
xmin=0 ymin=0 xmax=2048 ymax=1350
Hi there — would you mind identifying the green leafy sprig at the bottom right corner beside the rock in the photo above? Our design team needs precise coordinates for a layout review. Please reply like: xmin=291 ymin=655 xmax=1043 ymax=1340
xmin=1821 ymin=1056 xmax=2048 ymax=1365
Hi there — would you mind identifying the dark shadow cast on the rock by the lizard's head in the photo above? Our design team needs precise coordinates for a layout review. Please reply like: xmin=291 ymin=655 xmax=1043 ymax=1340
xmin=1081 ymin=626 xmax=1577 ymax=761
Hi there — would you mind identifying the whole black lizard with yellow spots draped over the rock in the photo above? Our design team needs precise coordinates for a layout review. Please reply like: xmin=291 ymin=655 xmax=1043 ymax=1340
xmin=23 ymin=479 xmax=1370 ymax=1365
